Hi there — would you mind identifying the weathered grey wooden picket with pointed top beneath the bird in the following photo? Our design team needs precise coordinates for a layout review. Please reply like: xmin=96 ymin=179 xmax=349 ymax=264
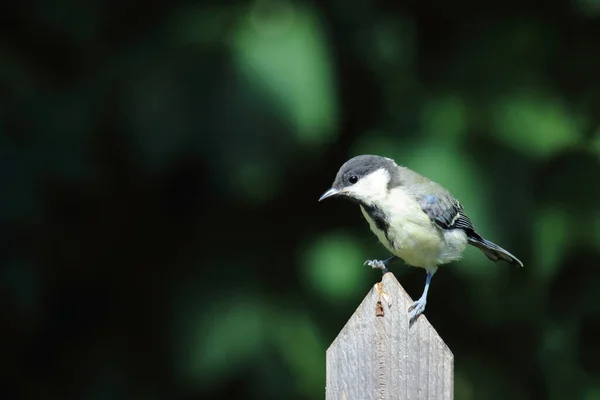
xmin=326 ymin=272 xmax=454 ymax=400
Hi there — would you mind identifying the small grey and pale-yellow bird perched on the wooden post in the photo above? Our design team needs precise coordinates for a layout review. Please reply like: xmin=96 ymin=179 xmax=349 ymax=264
xmin=318 ymin=154 xmax=523 ymax=326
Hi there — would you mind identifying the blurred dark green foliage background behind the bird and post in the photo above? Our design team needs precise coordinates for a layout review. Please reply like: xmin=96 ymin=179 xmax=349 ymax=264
xmin=0 ymin=0 xmax=600 ymax=400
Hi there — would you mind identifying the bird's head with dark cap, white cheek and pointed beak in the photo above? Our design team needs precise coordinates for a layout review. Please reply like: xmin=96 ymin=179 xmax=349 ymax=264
xmin=319 ymin=155 xmax=398 ymax=205
